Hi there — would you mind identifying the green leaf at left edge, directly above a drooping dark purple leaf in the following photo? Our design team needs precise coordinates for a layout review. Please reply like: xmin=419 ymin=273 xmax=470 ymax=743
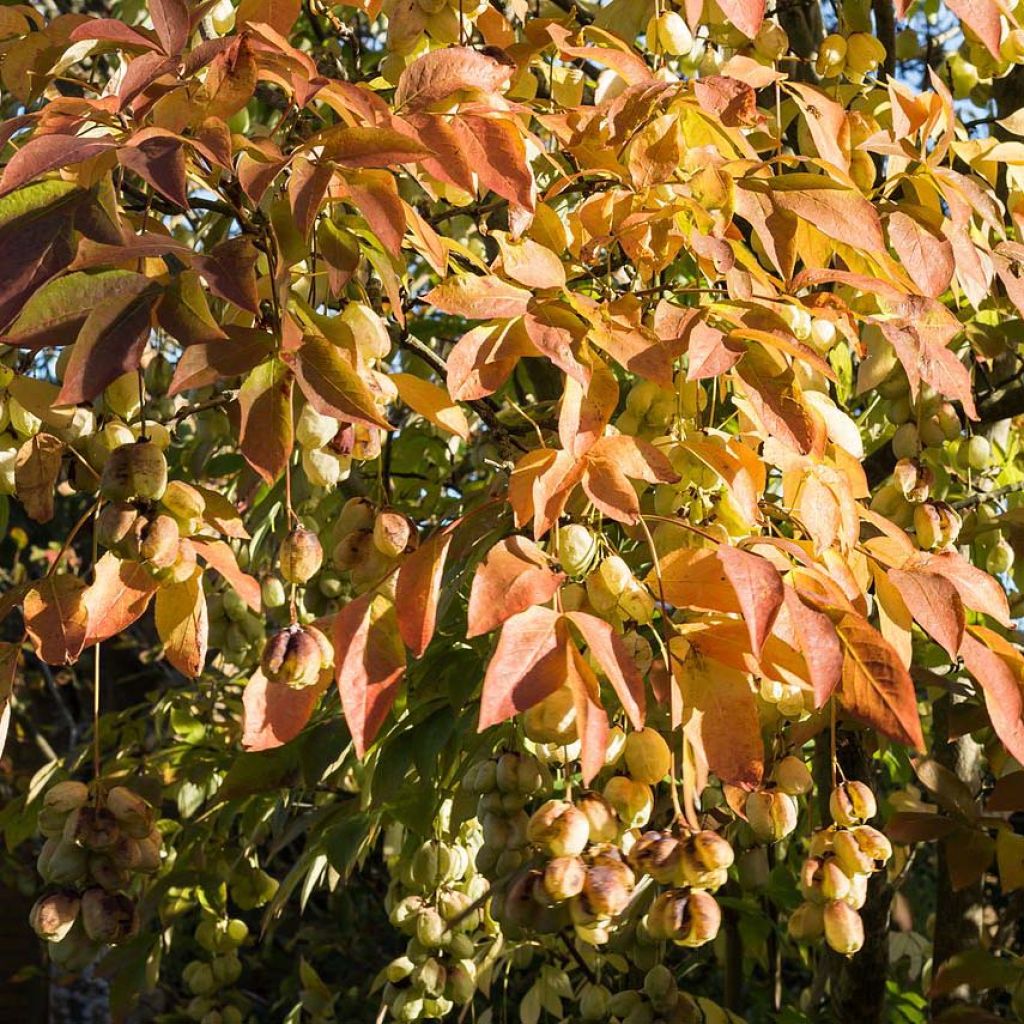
xmin=0 ymin=270 xmax=148 ymax=348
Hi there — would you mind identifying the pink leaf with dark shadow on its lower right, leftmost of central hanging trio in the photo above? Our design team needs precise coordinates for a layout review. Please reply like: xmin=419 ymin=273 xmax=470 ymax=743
xmin=479 ymin=606 xmax=568 ymax=732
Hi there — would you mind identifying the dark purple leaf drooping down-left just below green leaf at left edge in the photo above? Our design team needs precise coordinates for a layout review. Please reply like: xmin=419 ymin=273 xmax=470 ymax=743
xmin=57 ymin=279 xmax=160 ymax=406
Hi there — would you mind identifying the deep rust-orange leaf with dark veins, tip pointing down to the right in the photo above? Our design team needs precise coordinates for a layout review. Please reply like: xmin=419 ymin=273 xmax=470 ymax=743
xmin=836 ymin=612 xmax=925 ymax=751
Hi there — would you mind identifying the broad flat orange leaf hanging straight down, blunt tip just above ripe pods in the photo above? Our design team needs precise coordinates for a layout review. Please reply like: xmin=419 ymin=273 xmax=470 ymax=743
xmin=673 ymin=646 xmax=764 ymax=790
